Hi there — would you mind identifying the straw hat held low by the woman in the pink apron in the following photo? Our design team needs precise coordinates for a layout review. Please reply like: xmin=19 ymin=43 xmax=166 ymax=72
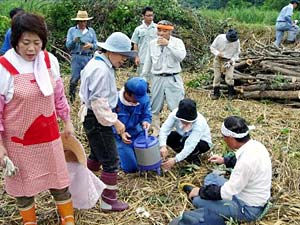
xmin=60 ymin=134 xmax=87 ymax=166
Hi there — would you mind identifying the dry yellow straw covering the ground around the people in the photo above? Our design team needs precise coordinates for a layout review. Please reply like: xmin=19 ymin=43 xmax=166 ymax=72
xmin=0 ymin=72 xmax=300 ymax=225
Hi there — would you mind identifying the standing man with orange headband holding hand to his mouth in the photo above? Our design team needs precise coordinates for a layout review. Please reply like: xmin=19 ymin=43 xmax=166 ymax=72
xmin=141 ymin=20 xmax=186 ymax=136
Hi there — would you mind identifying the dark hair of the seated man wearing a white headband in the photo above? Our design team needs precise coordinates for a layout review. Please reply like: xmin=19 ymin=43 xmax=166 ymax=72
xmin=224 ymin=116 xmax=250 ymax=143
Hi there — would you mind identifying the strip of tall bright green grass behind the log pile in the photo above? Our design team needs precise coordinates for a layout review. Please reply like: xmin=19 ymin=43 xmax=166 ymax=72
xmin=200 ymin=7 xmax=300 ymax=25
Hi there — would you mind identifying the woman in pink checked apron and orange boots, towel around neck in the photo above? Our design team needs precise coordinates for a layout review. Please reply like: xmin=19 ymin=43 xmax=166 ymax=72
xmin=0 ymin=13 xmax=75 ymax=225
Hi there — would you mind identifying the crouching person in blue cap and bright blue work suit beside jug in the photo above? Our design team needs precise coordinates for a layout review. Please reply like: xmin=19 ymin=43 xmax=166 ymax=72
xmin=114 ymin=77 xmax=151 ymax=173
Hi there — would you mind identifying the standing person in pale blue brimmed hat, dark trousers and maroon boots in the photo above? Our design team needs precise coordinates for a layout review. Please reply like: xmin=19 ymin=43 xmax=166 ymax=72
xmin=79 ymin=32 xmax=136 ymax=211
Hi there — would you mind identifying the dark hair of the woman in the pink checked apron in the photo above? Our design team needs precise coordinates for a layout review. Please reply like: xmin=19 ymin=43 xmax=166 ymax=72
xmin=11 ymin=13 xmax=48 ymax=50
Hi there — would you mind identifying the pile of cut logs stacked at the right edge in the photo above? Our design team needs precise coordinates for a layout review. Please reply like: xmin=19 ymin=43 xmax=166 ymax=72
xmin=207 ymin=36 xmax=300 ymax=107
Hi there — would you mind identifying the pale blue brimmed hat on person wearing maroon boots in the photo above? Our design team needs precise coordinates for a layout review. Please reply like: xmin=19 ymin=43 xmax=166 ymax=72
xmin=97 ymin=32 xmax=137 ymax=58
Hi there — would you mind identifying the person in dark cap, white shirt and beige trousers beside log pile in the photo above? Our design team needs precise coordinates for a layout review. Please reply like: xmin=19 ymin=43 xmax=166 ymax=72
xmin=210 ymin=29 xmax=241 ymax=100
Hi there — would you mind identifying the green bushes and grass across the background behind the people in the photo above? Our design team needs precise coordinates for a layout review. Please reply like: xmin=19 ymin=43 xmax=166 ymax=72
xmin=0 ymin=0 xmax=300 ymax=70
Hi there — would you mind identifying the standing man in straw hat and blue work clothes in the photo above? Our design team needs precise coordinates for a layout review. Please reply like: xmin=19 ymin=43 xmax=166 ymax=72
xmin=66 ymin=10 xmax=97 ymax=103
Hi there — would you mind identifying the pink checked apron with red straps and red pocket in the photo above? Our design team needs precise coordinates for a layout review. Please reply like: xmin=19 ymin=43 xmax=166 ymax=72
xmin=0 ymin=52 xmax=69 ymax=197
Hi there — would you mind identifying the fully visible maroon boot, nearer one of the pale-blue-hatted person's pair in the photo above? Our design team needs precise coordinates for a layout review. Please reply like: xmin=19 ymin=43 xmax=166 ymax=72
xmin=100 ymin=172 xmax=129 ymax=211
